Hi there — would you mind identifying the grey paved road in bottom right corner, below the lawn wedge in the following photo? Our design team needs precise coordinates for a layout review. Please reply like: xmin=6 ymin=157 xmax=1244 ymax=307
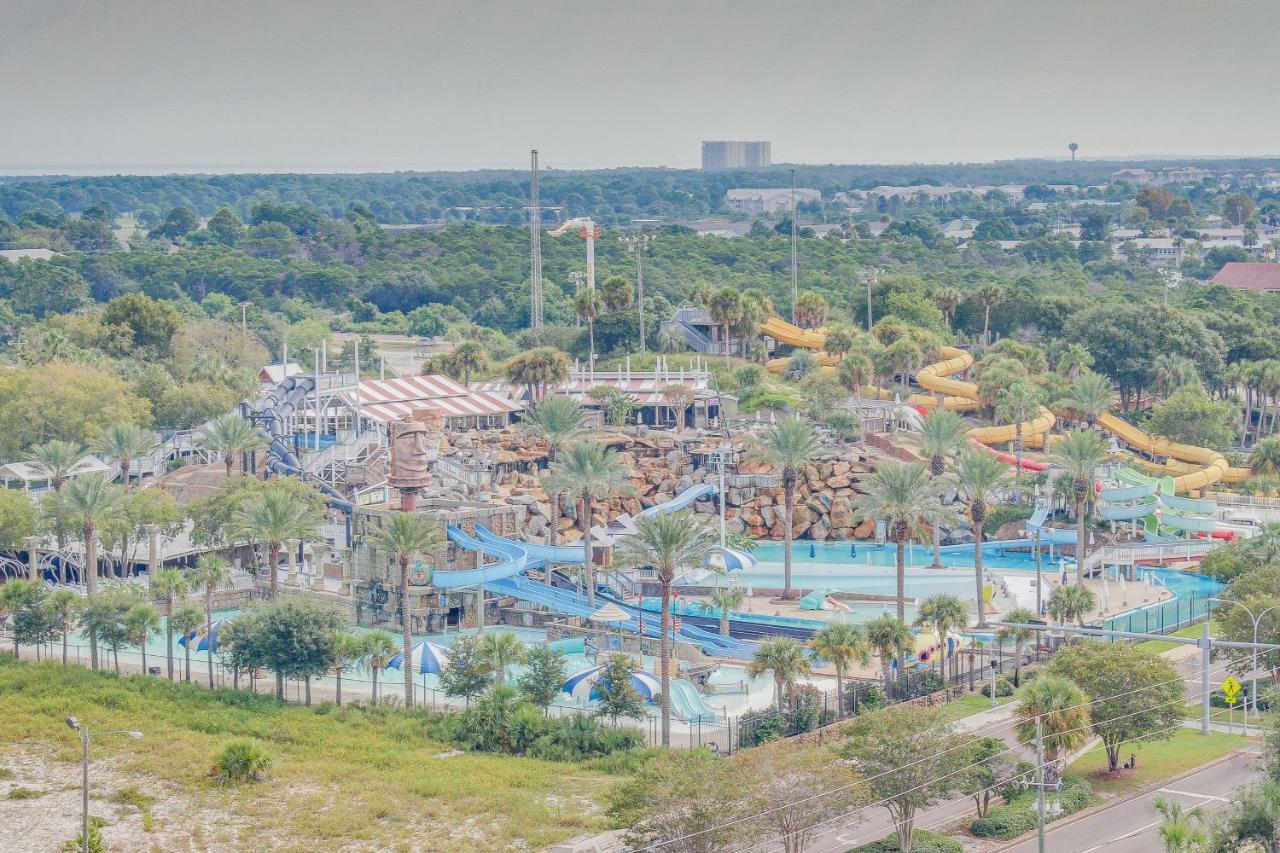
xmin=1000 ymin=751 xmax=1260 ymax=853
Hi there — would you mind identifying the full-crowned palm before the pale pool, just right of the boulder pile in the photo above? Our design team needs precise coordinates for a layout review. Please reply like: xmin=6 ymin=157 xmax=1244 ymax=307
xmin=854 ymin=460 xmax=954 ymax=622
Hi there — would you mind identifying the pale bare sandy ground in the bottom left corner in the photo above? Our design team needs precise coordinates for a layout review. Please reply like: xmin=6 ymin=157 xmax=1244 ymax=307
xmin=0 ymin=747 xmax=246 ymax=853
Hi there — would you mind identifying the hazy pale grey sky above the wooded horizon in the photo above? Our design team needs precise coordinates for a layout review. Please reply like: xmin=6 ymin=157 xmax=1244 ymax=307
xmin=0 ymin=0 xmax=1280 ymax=173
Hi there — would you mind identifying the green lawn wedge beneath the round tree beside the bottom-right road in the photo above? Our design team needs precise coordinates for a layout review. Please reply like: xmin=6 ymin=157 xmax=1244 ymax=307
xmin=1066 ymin=729 xmax=1245 ymax=794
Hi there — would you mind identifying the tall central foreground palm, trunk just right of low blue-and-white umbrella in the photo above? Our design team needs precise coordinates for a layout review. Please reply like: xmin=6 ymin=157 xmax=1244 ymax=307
xmin=616 ymin=510 xmax=713 ymax=747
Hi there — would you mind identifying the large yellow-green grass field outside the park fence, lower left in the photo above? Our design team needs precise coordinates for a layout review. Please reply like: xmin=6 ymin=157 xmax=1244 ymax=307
xmin=0 ymin=654 xmax=614 ymax=850
